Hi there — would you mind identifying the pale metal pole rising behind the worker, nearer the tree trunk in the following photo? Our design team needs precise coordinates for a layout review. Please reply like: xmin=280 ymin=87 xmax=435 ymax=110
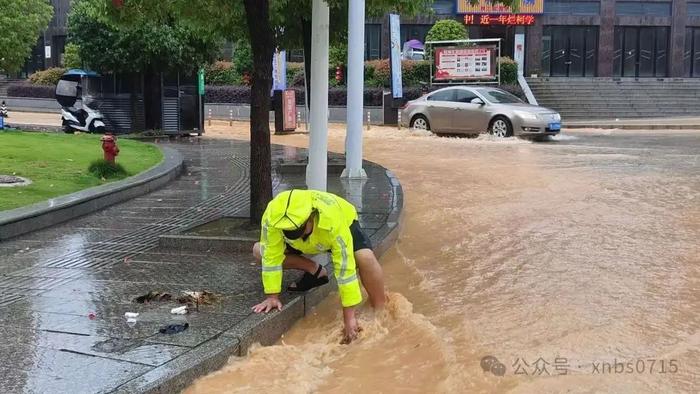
xmin=306 ymin=0 xmax=330 ymax=191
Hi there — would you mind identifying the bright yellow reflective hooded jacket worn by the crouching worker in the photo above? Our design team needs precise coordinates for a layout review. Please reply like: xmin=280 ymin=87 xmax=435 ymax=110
xmin=260 ymin=189 xmax=362 ymax=307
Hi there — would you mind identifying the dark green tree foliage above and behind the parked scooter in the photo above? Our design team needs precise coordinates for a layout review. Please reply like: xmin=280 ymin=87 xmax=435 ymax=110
xmin=68 ymin=0 xmax=220 ymax=72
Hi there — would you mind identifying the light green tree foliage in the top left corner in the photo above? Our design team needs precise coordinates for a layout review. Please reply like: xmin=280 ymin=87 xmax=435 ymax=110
xmin=0 ymin=0 xmax=53 ymax=72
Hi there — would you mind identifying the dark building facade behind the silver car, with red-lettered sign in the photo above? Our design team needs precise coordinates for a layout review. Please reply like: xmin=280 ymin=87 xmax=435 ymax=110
xmin=366 ymin=0 xmax=700 ymax=78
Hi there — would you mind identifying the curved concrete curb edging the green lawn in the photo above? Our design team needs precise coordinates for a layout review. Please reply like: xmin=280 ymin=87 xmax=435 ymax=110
xmin=0 ymin=147 xmax=183 ymax=240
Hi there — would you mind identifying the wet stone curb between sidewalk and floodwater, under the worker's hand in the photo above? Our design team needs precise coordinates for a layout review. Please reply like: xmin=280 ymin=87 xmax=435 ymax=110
xmin=113 ymin=161 xmax=403 ymax=394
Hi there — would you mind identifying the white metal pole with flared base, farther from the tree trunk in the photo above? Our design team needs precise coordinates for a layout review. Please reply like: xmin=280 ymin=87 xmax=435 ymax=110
xmin=341 ymin=0 xmax=367 ymax=178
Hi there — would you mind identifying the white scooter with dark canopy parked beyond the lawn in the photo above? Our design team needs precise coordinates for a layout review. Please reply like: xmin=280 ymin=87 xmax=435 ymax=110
xmin=56 ymin=69 xmax=105 ymax=133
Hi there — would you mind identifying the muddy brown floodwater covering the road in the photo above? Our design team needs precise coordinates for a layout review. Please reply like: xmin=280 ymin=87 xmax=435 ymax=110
xmin=186 ymin=123 xmax=700 ymax=393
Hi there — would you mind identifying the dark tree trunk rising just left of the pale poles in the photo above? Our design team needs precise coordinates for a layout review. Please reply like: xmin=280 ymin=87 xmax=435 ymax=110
xmin=244 ymin=0 xmax=275 ymax=223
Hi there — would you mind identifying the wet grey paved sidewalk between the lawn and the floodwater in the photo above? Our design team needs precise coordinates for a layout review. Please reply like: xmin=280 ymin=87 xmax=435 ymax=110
xmin=0 ymin=138 xmax=402 ymax=393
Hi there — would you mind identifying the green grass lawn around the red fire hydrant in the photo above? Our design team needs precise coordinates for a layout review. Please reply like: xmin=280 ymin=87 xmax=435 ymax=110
xmin=0 ymin=132 xmax=163 ymax=211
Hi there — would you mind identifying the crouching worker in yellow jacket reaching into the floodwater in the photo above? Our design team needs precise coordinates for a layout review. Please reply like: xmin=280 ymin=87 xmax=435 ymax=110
xmin=253 ymin=189 xmax=386 ymax=342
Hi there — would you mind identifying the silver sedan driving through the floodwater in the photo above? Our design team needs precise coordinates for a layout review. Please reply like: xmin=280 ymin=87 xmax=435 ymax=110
xmin=401 ymin=86 xmax=561 ymax=137
